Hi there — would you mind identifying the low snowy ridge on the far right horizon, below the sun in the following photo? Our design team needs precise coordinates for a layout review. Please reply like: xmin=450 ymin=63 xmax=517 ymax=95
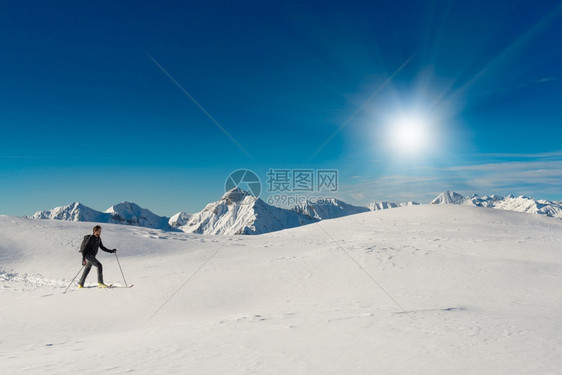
xmin=431 ymin=191 xmax=562 ymax=218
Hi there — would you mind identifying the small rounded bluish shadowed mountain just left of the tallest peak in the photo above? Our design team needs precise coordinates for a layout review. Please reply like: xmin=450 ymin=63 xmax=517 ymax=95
xmin=105 ymin=202 xmax=169 ymax=229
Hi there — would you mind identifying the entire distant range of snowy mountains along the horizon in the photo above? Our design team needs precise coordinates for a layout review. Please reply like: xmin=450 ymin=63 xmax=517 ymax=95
xmin=30 ymin=188 xmax=562 ymax=235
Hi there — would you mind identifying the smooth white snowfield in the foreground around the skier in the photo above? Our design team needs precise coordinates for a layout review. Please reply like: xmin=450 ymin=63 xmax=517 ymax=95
xmin=0 ymin=205 xmax=562 ymax=375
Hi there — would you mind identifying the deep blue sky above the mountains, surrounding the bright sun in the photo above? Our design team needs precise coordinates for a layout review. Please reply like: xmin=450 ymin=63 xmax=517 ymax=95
xmin=0 ymin=0 xmax=562 ymax=215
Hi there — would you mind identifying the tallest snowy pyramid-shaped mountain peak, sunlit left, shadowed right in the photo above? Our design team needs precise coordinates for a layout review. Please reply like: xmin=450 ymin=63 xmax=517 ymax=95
xmin=178 ymin=188 xmax=314 ymax=235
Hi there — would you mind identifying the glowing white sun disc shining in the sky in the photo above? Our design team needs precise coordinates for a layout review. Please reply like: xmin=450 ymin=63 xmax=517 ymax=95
xmin=388 ymin=115 xmax=431 ymax=155
